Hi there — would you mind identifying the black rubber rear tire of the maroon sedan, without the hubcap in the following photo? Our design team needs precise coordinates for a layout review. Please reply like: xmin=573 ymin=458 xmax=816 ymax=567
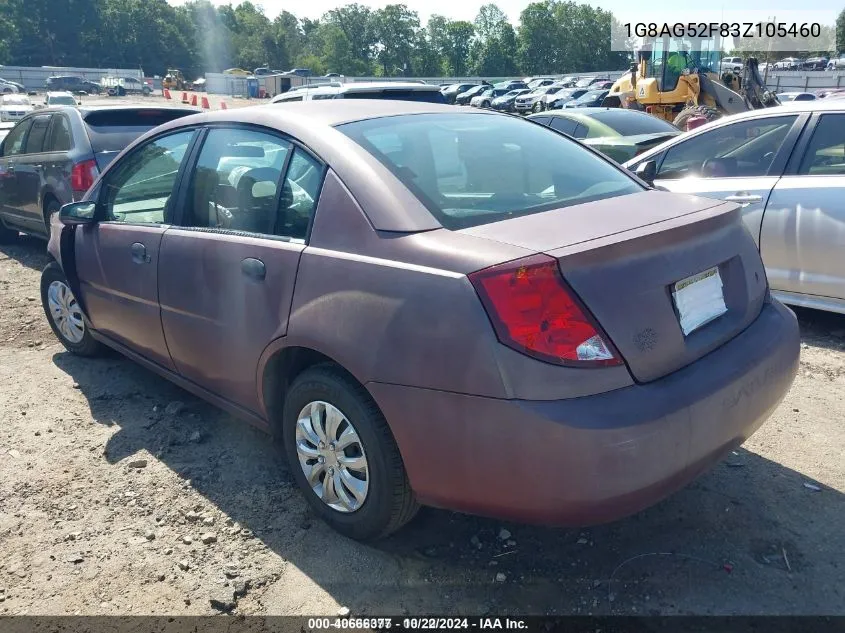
xmin=282 ymin=365 xmax=419 ymax=541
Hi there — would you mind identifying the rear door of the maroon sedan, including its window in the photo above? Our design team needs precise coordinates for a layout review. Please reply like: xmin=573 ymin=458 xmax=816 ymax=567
xmin=159 ymin=127 xmax=324 ymax=412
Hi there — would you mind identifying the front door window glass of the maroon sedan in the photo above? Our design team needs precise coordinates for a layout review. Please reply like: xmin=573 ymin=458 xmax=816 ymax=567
xmin=101 ymin=130 xmax=194 ymax=224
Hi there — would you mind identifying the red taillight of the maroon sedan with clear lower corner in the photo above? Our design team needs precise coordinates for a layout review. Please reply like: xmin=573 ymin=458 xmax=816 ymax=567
xmin=469 ymin=255 xmax=622 ymax=367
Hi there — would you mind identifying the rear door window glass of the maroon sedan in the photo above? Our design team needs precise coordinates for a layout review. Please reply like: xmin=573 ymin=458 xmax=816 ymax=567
xmin=187 ymin=129 xmax=323 ymax=240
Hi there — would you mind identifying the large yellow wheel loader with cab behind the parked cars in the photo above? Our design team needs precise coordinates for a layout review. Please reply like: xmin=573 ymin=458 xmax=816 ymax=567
xmin=602 ymin=35 xmax=780 ymax=129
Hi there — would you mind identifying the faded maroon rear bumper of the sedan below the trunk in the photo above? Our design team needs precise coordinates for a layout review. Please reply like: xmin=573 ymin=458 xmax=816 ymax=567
xmin=368 ymin=302 xmax=799 ymax=525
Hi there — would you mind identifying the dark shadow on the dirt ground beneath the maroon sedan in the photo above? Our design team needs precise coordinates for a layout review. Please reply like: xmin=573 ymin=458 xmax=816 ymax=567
xmin=53 ymin=344 xmax=845 ymax=614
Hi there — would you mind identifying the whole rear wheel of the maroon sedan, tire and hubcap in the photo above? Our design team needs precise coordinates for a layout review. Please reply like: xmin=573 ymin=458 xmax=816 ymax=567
xmin=282 ymin=365 xmax=419 ymax=541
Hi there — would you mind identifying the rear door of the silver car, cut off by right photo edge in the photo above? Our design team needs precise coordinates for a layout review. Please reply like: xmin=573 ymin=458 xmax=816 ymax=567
xmin=760 ymin=112 xmax=845 ymax=309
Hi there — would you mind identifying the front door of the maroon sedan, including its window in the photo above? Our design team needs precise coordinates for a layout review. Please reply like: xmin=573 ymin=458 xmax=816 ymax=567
xmin=75 ymin=130 xmax=196 ymax=370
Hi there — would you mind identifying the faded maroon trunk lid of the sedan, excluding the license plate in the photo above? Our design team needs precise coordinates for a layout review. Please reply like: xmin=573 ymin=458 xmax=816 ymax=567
xmin=462 ymin=191 xmax=767 ymax=382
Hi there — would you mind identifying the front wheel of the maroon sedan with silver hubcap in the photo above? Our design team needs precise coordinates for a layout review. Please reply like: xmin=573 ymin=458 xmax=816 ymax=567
xmin=41 ymin=262 xmax=105 ymax=356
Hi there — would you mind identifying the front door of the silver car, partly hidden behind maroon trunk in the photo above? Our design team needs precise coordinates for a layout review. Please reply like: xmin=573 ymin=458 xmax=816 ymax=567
xmin=649 ymin=114 xmax=809 ymax=246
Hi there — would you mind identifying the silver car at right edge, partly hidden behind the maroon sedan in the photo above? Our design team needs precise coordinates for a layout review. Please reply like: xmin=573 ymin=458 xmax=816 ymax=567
xmin=625 ymin=99 xmax=845 ymax=314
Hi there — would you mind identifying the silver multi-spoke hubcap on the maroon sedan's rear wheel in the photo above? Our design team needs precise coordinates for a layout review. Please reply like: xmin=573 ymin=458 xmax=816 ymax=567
xmin=296 ymin=400 xmax=370 ymax=512
